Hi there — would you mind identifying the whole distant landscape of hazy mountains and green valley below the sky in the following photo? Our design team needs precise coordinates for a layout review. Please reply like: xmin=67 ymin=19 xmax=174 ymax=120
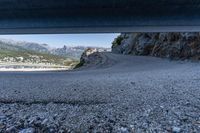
xmin=0 ymin=39 xmax=110 ymax=69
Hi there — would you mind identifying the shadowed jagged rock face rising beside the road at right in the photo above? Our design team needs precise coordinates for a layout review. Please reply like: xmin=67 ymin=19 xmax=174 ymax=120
xmin=112 ymin=33 xmax=200 ymax=60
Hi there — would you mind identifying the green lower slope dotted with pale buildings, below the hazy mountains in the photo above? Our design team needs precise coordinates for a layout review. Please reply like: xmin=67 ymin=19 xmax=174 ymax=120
xmin=0 ymin=41 xmax=78 ymax=69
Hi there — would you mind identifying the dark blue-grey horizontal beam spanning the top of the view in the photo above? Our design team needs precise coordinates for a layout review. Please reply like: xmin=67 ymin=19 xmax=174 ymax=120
xmin=0 ymin=0 xmax=200 ymax=34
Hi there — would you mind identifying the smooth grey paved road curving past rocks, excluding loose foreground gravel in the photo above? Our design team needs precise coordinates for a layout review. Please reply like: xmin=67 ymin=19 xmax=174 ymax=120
xmin=0 ymin=53 xmax=200 ymax=104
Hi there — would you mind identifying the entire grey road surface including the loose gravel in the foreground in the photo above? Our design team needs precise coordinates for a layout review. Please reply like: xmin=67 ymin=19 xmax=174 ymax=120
xmin=0 ymin=53 xmax=200 ymax=133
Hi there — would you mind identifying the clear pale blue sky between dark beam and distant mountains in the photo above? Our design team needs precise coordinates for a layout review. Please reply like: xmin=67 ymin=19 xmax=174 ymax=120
xmin=0 ymin=33 xmax=119 ymax=47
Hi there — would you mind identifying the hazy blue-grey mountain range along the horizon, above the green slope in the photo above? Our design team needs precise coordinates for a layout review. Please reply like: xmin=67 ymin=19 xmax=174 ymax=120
xmin=0 ymin=39 xmax=108 ymax=60
